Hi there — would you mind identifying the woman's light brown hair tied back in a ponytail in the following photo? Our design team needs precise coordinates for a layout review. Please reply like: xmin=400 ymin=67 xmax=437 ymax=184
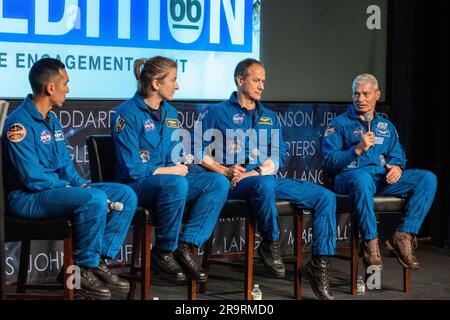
xmin=134 ymin=56 xmax=177 ymax=98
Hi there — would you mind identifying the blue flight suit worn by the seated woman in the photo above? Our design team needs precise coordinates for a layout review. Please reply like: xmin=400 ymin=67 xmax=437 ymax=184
xmin=111 ymin=93 xmax=230 ymax=251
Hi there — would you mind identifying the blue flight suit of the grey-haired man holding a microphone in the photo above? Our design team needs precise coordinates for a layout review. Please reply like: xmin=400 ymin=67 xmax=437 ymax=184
xmin=322 ymin=105 xmax=437 ymax=240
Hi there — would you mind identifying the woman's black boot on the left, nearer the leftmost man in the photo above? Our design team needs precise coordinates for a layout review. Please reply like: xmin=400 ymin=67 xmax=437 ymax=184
xmin=151 ymin=248 xmax=186 ymax=284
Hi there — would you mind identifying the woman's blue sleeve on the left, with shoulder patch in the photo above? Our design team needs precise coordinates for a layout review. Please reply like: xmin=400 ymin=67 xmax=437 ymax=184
xmin=111 ymin=115 xmax=159 ymax=180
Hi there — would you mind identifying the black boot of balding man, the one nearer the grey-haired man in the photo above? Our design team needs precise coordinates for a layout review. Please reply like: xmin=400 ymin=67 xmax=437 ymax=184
xmin=302 ymin=256 xmax=334 ymax=300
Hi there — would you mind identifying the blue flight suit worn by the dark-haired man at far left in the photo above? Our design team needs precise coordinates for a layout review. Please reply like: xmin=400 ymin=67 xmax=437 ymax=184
xmin=3 ymin=95 xmax=137 ymax=268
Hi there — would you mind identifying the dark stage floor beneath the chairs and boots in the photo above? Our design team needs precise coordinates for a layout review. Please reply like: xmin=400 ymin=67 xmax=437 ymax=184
xmin=3 ymin=241 xmax=450 ymax=301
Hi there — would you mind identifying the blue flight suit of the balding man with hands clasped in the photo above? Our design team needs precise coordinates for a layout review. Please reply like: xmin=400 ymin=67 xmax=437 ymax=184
xmin=194 ymin=92 xmax=336 ymax=255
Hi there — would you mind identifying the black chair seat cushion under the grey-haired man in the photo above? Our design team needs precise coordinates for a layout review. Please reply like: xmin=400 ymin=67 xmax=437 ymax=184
xmin=336 ymin=194 xmax=406 ymax=213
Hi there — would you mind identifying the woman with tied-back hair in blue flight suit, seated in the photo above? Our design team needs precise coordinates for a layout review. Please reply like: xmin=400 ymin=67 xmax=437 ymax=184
xmin=111 ymin=56 xmax=230 ymax=282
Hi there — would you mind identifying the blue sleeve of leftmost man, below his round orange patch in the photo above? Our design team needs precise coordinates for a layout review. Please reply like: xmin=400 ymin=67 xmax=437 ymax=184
xmin=4 ymin=126 xmax=70 ymax=191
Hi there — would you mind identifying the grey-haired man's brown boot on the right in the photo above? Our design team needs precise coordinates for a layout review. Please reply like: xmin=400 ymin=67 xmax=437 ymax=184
xmin=389 ymin=231 xmax=420 ymax=269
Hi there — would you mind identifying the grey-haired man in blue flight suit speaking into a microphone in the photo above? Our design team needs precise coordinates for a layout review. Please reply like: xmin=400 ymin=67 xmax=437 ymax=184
xmin=322 ymin=74 xmax=437 ymax=269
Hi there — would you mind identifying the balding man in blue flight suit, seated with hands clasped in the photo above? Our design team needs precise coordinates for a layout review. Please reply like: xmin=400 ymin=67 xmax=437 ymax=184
xmin=194 ymin=59 xmax=336 ymax=299
